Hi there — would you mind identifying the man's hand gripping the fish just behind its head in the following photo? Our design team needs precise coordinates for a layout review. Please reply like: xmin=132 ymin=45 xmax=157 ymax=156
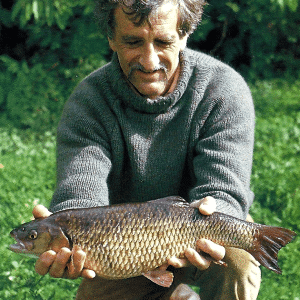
xmin=32 ymin=205 xmax=96 ymax=279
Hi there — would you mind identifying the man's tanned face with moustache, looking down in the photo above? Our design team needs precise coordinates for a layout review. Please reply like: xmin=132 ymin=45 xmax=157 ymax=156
xmin=109 ymin=1 xmax=187 ymax=99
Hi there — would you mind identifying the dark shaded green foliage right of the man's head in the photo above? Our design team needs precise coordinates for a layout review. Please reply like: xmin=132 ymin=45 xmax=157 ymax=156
xmin=190 ymin=0 xmax=300 ymax=79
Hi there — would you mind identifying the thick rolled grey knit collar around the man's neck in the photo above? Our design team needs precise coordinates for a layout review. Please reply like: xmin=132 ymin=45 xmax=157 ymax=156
xmin=107 ymin=49 xmax=192 ymax=114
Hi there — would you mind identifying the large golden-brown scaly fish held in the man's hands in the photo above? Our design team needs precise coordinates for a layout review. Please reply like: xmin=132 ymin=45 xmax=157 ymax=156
xmin=10 ymin=196 xmax=296 ymax=287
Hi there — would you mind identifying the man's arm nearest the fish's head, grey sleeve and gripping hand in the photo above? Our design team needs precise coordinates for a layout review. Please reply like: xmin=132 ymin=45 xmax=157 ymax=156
xmin=33 ymin=81 xmax=113 ymax=278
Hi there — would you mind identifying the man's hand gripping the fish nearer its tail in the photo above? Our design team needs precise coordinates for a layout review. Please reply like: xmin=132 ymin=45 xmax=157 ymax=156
xmin=168 ymin=196 xmax=225 ymax=270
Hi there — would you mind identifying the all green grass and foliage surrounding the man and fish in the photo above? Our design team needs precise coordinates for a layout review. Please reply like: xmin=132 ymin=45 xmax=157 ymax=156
xmin=0 ymin=0 xmax=300 ymax=300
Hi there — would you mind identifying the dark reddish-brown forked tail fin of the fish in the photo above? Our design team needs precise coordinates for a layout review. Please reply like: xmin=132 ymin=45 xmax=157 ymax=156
xmin=249 ymin=225 xmax=297 ymax=274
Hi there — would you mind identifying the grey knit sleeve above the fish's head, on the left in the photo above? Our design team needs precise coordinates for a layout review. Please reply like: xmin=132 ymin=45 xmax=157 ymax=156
xmin=50 ymin=78 xmax=112 ymax=212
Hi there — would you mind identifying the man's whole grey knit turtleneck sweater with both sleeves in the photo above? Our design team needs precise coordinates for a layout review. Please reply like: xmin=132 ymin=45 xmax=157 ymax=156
xmin=50 ymin=49 xmax=254 ymax=218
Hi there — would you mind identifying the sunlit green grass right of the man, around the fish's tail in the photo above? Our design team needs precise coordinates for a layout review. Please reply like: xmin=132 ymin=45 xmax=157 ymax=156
xmin=251 ymin=81 xmax=300 ymax=300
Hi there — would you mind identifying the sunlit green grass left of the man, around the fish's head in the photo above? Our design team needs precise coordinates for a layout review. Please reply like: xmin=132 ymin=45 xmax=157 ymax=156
xmin=0 ymin=128 xmax=78 ymax=300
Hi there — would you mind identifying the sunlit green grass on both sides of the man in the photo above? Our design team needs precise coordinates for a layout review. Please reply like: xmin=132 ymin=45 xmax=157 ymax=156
xmin=0 ymin=81 xmax=300 ymax=300
